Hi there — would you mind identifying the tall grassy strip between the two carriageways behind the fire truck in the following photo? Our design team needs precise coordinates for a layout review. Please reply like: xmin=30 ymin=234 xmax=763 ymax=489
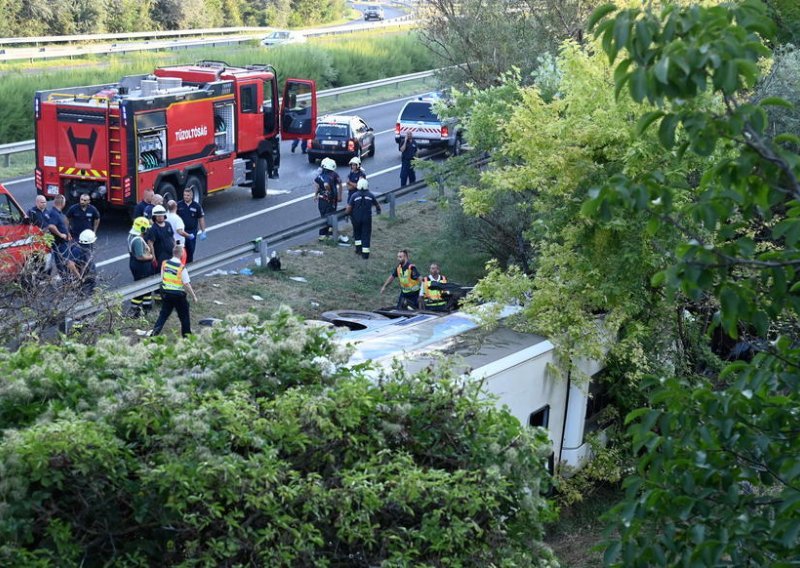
xmin=0 ymin=32 xmax=434 ymax=179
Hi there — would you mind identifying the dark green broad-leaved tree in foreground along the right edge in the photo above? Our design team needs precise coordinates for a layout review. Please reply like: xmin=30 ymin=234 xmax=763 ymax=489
xmin=584 ymin=0 xmax=800 ymax=566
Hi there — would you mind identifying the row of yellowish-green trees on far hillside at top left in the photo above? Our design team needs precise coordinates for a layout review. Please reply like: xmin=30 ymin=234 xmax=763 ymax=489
xmin=0 ymin=0 xmax=347 ymax=37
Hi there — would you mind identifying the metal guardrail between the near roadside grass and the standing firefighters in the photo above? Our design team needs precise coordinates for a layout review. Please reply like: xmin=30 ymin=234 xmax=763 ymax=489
xmin=72 ymin=178 xmax=434 ymax=320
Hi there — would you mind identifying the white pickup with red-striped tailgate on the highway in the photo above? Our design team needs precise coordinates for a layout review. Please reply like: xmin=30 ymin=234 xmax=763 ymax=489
xmin=394 ymin=93 xmax=464 ymax=156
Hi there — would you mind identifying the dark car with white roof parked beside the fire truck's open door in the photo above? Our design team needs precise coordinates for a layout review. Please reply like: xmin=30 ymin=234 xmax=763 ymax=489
xmin=308 ymin=114 xmax=375 ymax=164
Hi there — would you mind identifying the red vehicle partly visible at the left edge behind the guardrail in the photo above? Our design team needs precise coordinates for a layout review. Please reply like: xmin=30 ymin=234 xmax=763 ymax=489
xmin=0 ymin=184 xmax=49 ymax=281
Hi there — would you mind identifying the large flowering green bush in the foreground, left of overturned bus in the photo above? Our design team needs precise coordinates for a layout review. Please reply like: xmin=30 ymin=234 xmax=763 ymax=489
xmin=0 ymin=310 xmax=553 ymax=566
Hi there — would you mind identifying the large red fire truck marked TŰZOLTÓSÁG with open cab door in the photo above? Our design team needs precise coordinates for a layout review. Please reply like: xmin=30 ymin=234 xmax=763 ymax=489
xmin=34 ymin=61 xmax=317 ymax=208
